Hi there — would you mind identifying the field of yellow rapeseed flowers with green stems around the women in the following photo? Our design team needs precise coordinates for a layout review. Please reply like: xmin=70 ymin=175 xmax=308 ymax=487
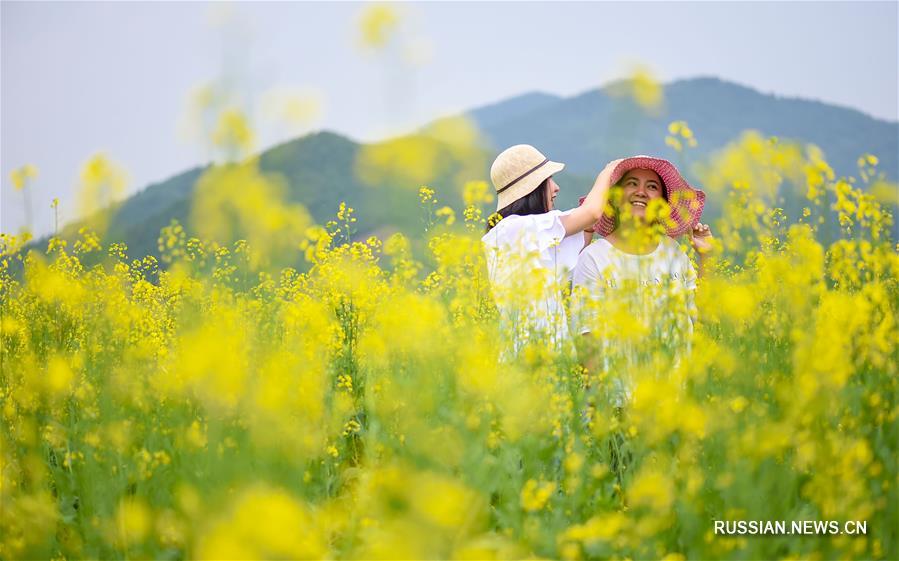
xmin=0 ymin=124 xmax=899 ymax=561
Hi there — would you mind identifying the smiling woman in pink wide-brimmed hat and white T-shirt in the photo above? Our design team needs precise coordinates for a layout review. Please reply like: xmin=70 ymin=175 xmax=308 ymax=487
xmin=572 ymin=156 xmax=712 ymax=402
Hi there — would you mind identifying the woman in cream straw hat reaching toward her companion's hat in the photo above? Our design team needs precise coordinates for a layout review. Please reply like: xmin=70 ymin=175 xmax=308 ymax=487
xmin=481 ymin=144 xmax=617 ymax=352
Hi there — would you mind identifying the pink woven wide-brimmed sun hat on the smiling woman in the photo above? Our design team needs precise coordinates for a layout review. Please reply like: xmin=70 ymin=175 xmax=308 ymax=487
xmin=594 ymin=156 xmax=705 ymax=238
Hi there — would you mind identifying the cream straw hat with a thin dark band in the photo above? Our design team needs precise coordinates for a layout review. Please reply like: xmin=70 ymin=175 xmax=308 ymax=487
xmin=490 ymin=144 xmax=565 ymax=210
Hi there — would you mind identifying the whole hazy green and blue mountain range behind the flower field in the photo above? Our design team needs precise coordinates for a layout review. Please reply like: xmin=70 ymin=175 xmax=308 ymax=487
xmin=31 ymin=78 xmax=899 ymax=262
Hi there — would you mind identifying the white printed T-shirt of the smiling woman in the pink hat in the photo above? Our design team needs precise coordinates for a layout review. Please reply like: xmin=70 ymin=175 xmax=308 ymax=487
xmin=572 ymin=236 xmax=696 ymax=405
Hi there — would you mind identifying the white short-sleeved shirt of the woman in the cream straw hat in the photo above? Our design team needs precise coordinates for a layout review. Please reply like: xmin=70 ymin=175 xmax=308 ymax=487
xmin=481 ymin=210 xmax=584 ymax=352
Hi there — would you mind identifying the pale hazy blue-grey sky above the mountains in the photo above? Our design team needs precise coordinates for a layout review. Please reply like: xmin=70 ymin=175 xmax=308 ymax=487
xmin=0 ymin=1 xmax=899 ymax=233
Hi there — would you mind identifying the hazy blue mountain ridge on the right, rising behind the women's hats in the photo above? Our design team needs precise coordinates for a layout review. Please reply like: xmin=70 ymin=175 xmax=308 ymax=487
xmin=474 ymin=77 xmax=899 ymax=184
